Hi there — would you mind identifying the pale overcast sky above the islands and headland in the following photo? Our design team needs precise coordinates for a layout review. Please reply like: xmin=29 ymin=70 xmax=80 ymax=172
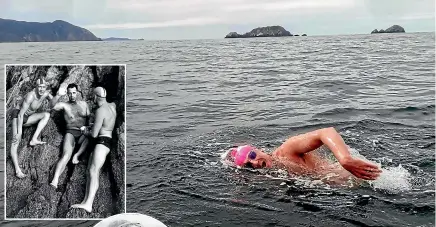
xmin=0 ymin=0 xmax=435 ymax=40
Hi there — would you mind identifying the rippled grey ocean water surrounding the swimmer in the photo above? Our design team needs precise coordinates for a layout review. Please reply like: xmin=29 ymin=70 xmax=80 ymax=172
xmin=0 ymin=33 xmax=435 ymax=226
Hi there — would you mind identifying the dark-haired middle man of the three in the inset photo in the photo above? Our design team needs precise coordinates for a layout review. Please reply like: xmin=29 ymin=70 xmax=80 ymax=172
xmin=50 ymin=84 xmax=90 ymax=188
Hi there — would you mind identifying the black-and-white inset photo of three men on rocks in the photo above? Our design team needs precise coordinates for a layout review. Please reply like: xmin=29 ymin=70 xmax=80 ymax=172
xmin=5 ymin=65 xmax=126 ymax=220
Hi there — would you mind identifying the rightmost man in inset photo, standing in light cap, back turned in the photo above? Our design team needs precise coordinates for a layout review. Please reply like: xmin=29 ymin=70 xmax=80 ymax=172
xmin=71 ymin=87 xmax=117 ymax=213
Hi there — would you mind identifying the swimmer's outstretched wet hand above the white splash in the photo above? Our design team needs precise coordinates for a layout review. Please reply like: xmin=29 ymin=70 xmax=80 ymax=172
xmin=341 ymin=157 xmax=382 ymax=180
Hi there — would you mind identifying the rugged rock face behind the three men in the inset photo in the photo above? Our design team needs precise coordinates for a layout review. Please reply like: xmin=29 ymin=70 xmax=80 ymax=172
xmin=5 ymin=66 xmax=125 ymax=218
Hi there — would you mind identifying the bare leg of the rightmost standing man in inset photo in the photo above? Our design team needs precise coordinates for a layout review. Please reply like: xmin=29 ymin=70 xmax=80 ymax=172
xmin=71 ymin=144 xmax=109 ymax=213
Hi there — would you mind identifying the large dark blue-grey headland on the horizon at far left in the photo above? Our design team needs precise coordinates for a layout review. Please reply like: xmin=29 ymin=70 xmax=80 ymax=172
xmin=0 ymin=18 xmax=101 ymax=42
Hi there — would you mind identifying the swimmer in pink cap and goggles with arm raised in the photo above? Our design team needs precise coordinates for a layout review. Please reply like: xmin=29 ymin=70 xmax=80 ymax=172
xmin=230 ymin=128 xmax=381 ymax=182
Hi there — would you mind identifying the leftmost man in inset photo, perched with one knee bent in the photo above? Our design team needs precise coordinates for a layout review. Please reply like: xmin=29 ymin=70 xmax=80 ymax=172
xmin=11 ymin=77 xmax=64 ymax=178
